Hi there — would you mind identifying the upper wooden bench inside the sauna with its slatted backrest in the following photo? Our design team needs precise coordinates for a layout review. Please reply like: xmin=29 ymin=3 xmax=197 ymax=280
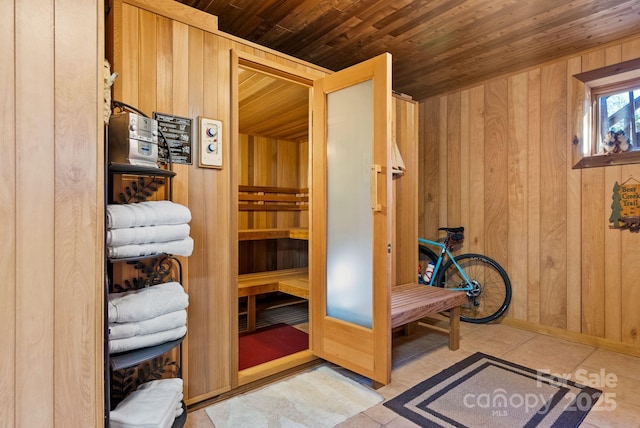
xmin=238 ymin=186 xmax=309 ymax=241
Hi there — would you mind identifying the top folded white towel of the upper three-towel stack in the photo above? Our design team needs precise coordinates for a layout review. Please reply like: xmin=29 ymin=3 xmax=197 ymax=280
xmin=107 ymin=201 xmax=191 ymax=229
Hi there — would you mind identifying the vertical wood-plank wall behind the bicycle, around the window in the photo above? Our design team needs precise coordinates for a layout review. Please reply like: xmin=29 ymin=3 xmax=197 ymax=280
xmin=419 ymin=36 xmax=640 ymax=352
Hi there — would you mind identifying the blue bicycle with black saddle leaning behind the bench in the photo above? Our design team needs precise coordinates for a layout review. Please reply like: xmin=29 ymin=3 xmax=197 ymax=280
xmin=418 ymin=227 xmax=511 ymax=324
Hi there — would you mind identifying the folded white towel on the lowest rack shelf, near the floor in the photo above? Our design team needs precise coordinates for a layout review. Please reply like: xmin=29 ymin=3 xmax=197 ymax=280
xmin=109 ymin=378 xmax=182 ymax=428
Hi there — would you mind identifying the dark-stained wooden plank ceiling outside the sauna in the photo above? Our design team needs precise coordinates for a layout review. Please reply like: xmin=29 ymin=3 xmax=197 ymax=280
xmin=179 ymin=0 xmax=640 ymax=100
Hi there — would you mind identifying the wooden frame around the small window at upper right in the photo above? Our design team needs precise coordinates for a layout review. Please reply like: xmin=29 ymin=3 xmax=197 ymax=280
xmin=573 ymin=58 xmax=640 ymax=169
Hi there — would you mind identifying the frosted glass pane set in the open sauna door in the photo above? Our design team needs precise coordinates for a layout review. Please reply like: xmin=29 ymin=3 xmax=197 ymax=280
xmin=327 ymin=80 xmax=373 ymax=328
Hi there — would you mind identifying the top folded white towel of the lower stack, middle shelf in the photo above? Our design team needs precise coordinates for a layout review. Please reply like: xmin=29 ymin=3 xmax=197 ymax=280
xmin=107 ymin=281 xmax=189 ymax=323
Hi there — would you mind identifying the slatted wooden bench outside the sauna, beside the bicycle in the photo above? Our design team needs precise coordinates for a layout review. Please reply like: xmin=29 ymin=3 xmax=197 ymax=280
xmin=391 ymin=283 xmax=467 ymax=351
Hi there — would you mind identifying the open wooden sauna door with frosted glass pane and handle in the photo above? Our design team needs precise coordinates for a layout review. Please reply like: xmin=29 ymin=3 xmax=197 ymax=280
xmin=309 ymin=54 xmax=392 ymax=384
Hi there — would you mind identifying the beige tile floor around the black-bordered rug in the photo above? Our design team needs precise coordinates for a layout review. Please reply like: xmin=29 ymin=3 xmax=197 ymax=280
xmin=186 ymin=323 xmax=640 ymax=428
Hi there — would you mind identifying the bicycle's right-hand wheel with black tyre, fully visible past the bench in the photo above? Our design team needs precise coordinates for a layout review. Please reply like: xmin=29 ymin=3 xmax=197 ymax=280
xmin=435 ymin=254 xmax=511 ymax=324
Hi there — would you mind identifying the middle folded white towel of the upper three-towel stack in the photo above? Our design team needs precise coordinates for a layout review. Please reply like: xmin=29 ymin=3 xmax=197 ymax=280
xmin=107 ymin=223 xmax=191 ymax=247
